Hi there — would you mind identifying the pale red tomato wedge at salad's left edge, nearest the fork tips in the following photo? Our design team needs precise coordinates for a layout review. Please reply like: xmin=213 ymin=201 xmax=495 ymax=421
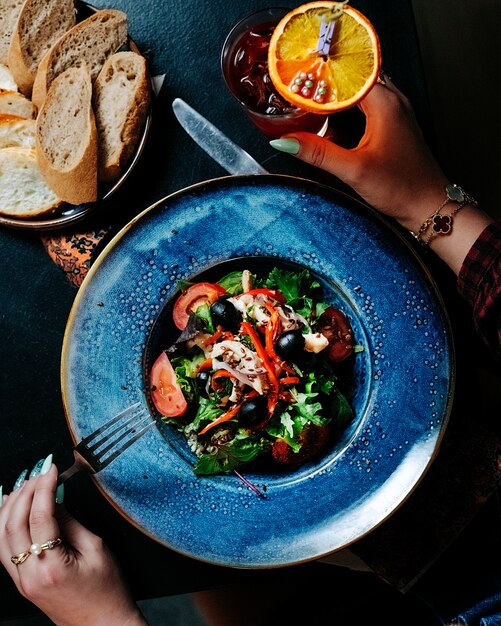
xmin=150 ymin=352 xmax=188 ymax=417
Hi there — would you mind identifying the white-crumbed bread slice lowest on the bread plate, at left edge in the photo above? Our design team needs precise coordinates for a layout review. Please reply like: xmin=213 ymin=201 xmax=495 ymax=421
xmin=0 ymin=148 xmax=61 ymax=218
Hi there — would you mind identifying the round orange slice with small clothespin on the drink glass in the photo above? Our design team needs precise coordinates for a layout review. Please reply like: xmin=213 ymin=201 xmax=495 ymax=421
xmin=268 ymin=2 xmax=381 ymax=114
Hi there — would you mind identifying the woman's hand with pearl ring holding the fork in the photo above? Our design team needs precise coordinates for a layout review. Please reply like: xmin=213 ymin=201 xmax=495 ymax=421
xmin=0 ymin=456 xmax=146 ymax=626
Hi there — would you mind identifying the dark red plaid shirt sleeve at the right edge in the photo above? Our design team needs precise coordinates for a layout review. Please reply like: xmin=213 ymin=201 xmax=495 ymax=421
xmin=457 ymin=221 xmax=501 ymax=357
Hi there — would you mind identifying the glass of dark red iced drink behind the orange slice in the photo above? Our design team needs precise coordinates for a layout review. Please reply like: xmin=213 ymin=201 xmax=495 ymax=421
xmin=221 ymin=9 xmax=327 ymax=139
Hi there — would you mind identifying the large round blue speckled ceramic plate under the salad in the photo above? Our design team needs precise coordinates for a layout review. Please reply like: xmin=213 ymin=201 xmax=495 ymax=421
xmin=62 ymin=175 xmax=454 ymax=568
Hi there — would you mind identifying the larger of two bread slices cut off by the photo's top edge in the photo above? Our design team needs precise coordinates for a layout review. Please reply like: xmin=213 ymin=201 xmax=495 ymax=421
xmin=8 ymin=0 xmax=76 ymax=96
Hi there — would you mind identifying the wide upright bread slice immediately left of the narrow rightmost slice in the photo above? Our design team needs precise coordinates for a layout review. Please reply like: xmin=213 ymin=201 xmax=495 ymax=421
xmin=36 ymin=64 xmax=97 ymax=204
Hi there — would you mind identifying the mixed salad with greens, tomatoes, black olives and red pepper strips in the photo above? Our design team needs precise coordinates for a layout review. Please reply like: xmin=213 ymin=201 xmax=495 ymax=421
xmin=150 ymin=267 xmax=362 ymax=475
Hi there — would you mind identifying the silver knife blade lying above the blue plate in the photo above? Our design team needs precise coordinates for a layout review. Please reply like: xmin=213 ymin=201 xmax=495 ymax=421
xmin=172 ymin=98 xmax=268 ymax=174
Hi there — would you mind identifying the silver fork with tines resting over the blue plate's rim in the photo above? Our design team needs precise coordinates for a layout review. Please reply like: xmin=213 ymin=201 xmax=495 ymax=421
xmin=58 ymin=402 xmax=155 ymax=484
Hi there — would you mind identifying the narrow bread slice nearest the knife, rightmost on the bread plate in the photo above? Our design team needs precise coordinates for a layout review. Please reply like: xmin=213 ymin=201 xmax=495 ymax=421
xmin=94 ymin=52 xmax=150 ymax=181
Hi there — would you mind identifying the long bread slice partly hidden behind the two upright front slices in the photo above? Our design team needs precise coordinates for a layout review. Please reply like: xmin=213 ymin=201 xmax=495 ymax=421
xmin=32 ymin=9 xmax=127 ymax=107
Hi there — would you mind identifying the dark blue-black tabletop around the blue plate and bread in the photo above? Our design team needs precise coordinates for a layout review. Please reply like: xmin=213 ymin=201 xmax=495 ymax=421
xmin=0 ymin=0 xmax=498 ymax=617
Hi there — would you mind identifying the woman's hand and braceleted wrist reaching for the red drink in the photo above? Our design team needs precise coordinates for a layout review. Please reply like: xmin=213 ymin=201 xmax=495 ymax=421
xmin=271 ymin=79 xmax=492 ymax=273
